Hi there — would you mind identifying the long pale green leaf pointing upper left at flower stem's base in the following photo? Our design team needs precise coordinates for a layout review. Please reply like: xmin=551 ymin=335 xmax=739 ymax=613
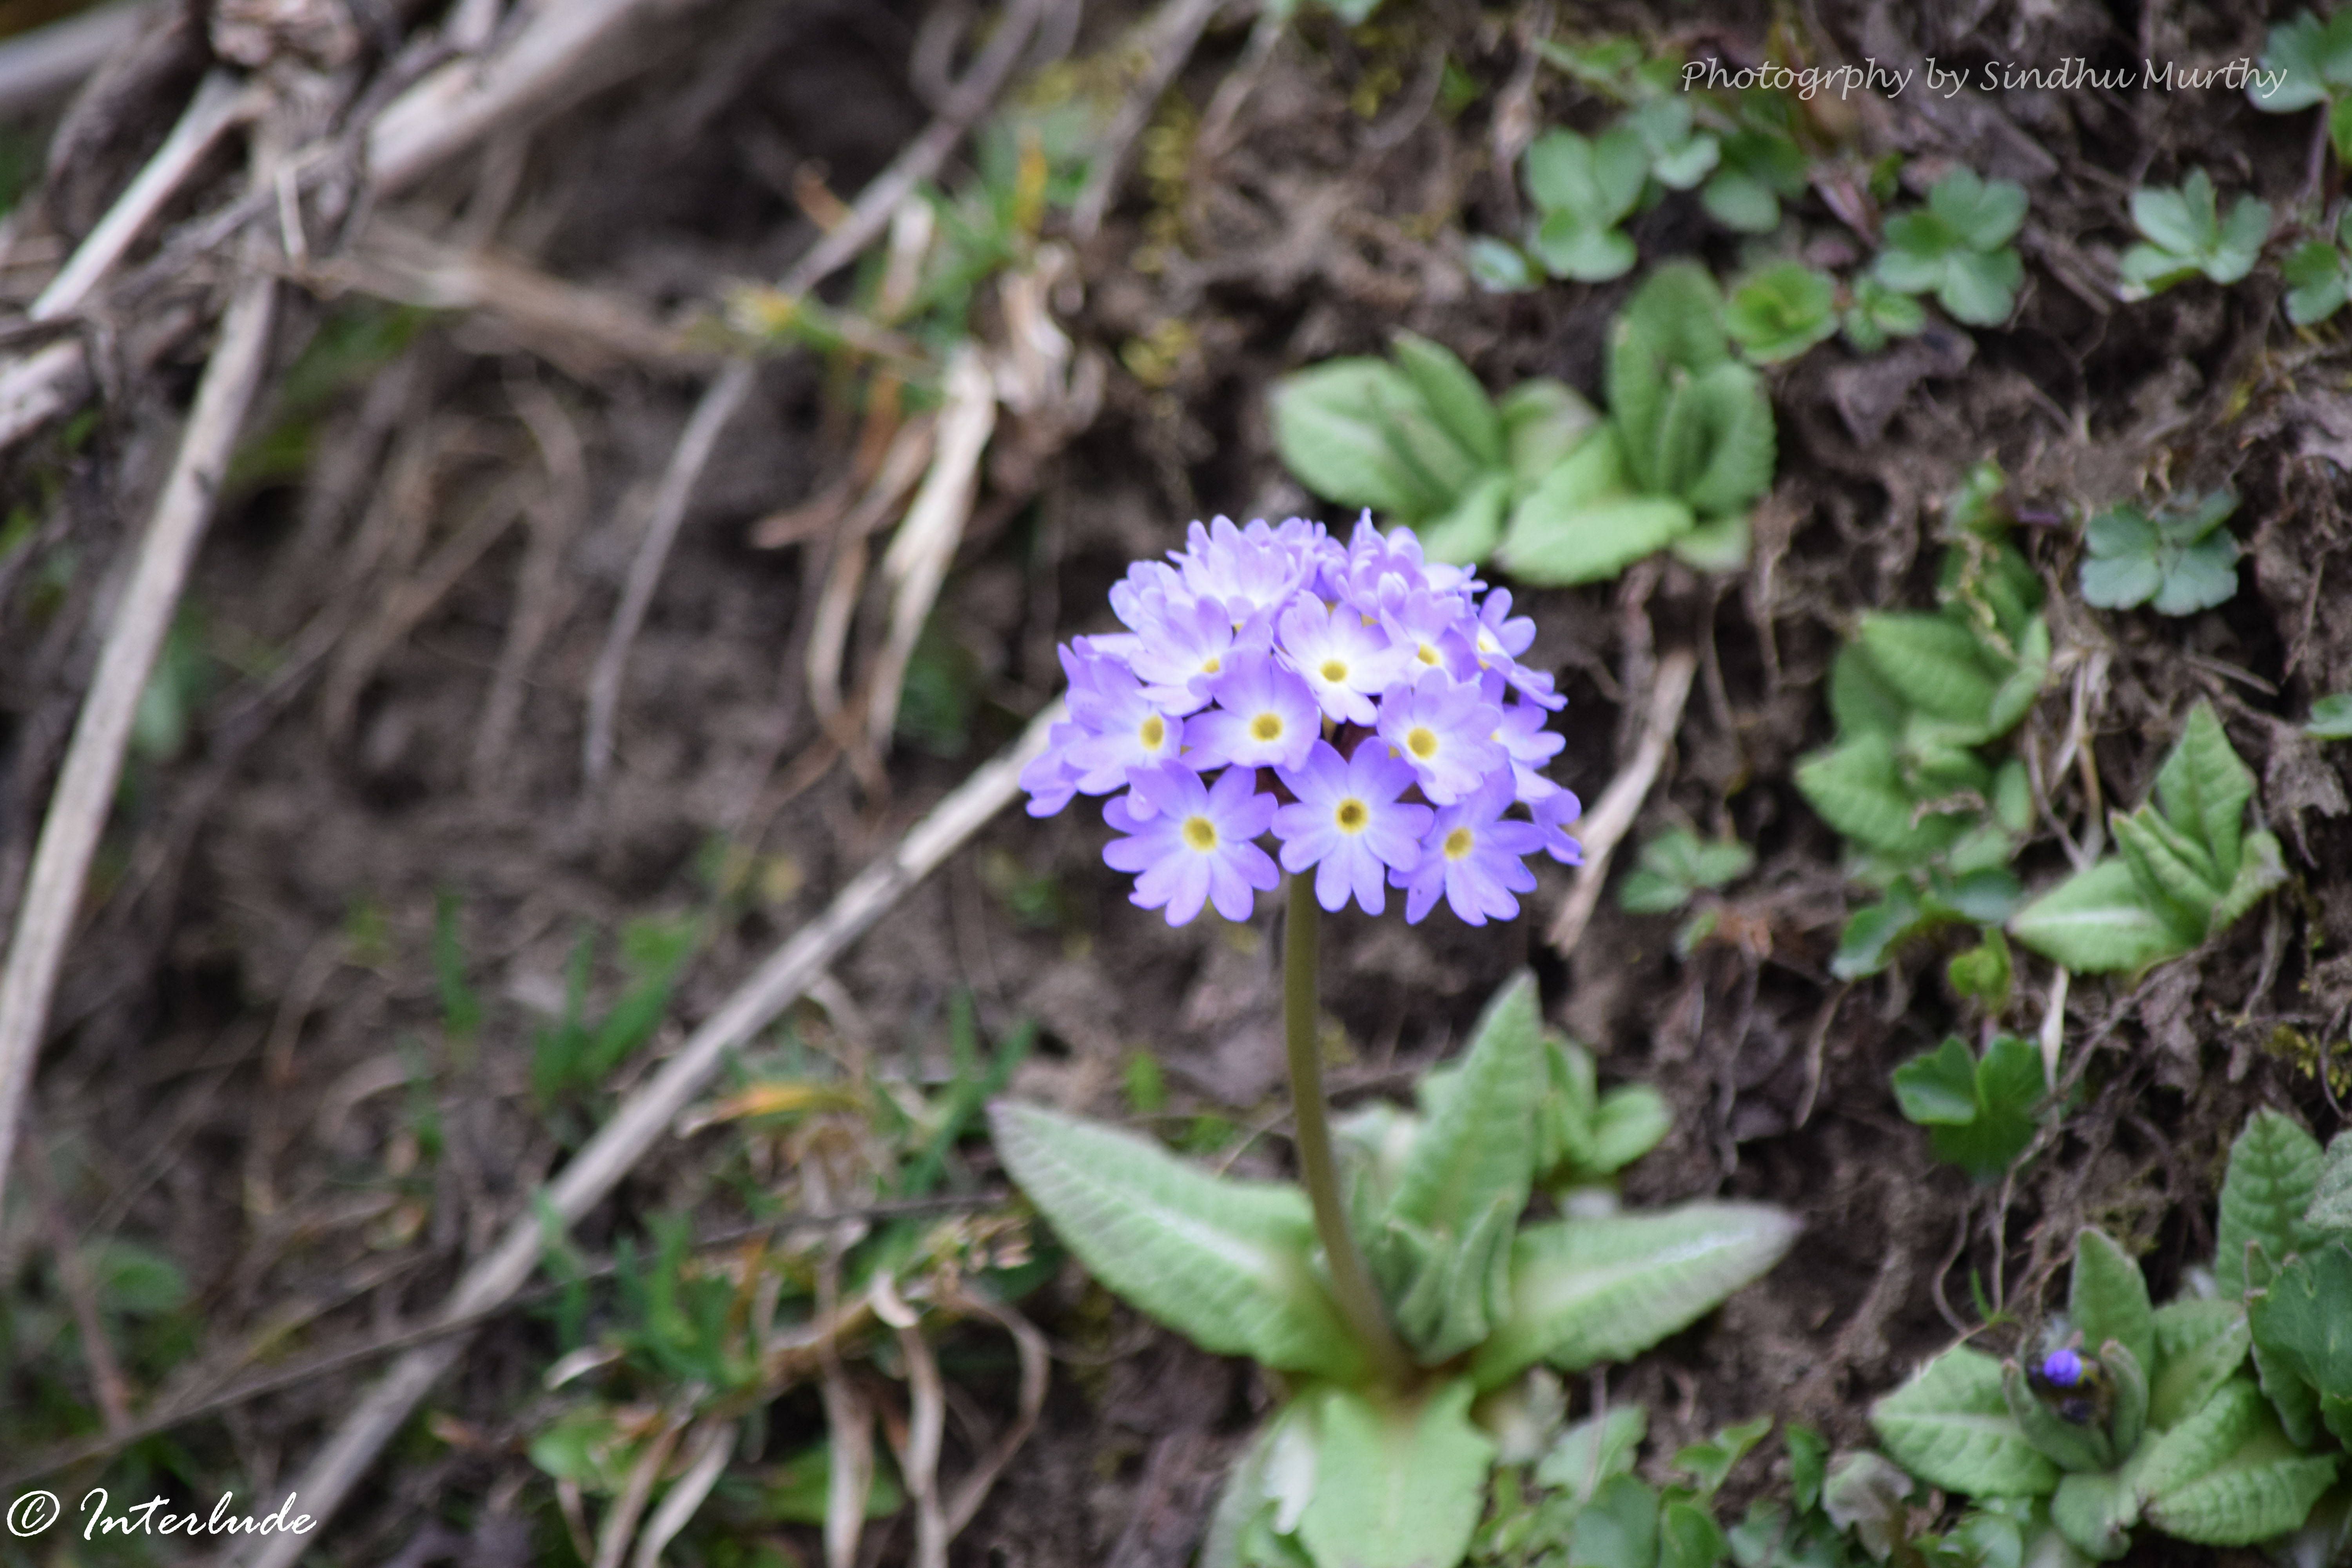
xmin=990 ymin=1100 xmax=1364 ymax=1380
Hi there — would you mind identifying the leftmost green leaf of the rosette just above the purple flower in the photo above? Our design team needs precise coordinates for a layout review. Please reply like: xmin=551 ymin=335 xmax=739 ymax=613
xmin=1270 ymin=358 xmax=1468 ymax=522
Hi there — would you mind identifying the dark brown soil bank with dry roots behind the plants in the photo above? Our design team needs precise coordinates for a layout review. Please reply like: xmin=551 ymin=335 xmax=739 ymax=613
xmin=0 ymin=0 xmax=2352 ymax=1568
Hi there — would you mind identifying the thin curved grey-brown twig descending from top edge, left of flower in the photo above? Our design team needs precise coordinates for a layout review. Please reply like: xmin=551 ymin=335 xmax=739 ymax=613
xmin=581 ymin=0 xmax=1044 ymax=790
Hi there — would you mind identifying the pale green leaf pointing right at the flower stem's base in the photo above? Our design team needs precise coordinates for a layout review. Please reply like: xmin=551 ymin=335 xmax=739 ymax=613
xmin=1470 ymin=1203 xmax=1799 ymax=1389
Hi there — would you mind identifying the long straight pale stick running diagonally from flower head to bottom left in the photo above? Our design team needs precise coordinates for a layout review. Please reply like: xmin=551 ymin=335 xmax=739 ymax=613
xmin=234 ymin=701 xmax=1063 ymax=1568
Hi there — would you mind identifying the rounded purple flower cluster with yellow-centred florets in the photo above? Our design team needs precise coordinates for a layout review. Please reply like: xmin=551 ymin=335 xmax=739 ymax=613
xmin=1021 ymin=512 xmax=1581 ymax=926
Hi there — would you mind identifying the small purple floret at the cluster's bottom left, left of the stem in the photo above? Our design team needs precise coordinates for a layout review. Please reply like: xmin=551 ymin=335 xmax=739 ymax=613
xmin=1103 ymin=762 xmax=1282 ymax=926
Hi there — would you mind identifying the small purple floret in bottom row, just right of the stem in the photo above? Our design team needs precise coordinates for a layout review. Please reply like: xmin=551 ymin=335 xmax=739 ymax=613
xmin=1275 ymin=738 xmax=1435 ymax=915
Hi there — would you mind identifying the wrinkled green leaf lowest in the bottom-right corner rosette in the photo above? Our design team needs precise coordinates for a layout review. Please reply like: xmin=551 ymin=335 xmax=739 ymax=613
xmin=2138 ymin=1377 xmax=2338 ymax=1547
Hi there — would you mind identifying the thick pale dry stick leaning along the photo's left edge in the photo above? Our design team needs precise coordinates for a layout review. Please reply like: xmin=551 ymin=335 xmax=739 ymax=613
xmin=0 ymin=275 xmax=278 ymax=1199
